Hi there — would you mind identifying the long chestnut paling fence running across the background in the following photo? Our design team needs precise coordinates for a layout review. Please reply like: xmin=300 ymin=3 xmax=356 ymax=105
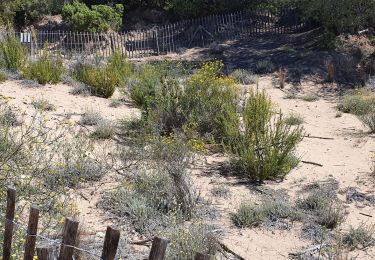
xmin=0 ymin=8 xmax=310 ymax=58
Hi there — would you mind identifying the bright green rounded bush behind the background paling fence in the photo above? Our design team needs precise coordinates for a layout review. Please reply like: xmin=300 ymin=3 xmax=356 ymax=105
xmin=62 ymin=0 xmax=124 ymax=32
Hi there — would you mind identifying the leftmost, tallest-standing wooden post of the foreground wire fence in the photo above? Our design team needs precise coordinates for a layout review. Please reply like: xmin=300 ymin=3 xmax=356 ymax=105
xmin=3 ymin=187 xmax=16 ymax=260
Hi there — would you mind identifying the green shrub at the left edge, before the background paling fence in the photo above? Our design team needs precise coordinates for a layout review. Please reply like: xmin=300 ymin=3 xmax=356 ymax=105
xmin=0 ymin=35 xmax=26 ymax=71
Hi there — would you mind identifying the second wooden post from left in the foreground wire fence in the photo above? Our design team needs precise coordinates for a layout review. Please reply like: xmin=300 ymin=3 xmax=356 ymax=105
xmin=23 ymin=205 xmax=39 ymax=260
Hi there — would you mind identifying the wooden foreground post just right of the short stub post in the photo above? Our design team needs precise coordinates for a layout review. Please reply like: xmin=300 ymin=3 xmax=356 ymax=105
xmin=59 ymin=218 xmax=79 ymax=260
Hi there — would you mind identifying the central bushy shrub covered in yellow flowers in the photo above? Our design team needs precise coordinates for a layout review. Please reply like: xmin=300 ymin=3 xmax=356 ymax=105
xmin=182 ymin=62 xmax=239 ymax=142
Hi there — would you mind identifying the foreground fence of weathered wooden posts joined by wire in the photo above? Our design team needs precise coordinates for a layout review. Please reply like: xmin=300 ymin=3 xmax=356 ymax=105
xmin=2 ymin=188 xmax=211 ymax=260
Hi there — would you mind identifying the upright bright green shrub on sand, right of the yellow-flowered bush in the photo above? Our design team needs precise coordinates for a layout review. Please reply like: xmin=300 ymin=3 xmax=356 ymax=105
xmin=226 ymin=90 xmax=303 ymax=181
